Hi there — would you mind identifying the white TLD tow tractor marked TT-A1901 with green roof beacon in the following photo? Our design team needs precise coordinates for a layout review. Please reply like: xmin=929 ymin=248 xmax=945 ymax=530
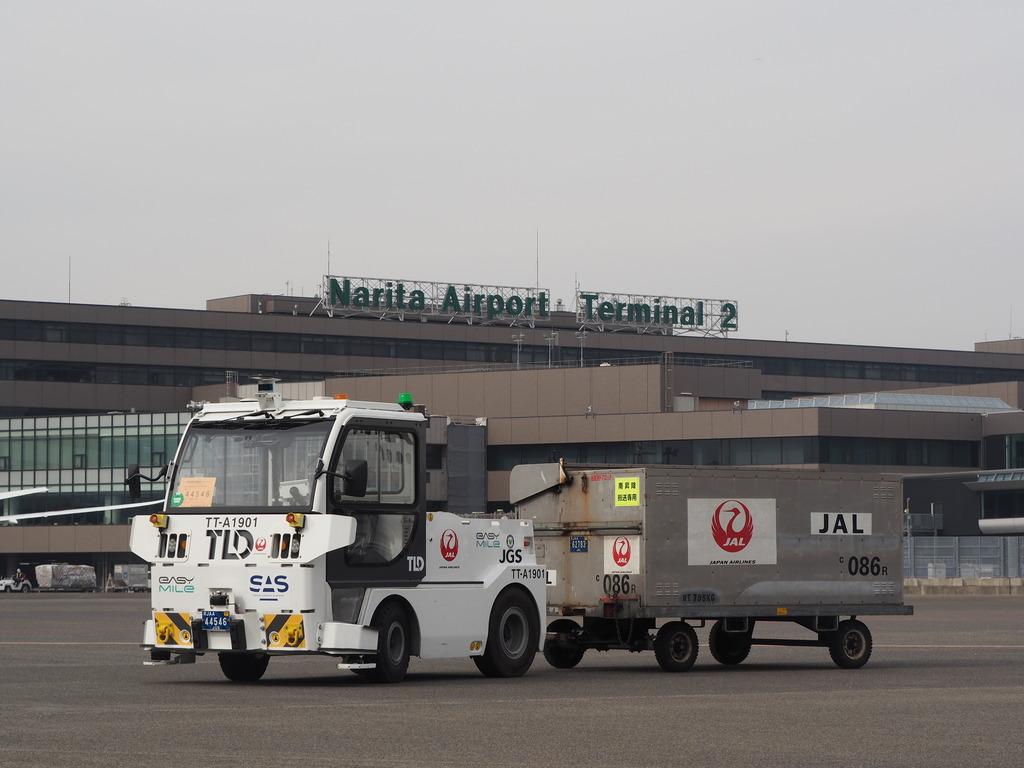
xmin=129 ymin=390 xmax=547 ymax=682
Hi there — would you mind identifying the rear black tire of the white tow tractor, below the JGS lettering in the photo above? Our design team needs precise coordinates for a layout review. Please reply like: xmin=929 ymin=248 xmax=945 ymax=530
xmin=473 ymin=589 xmax=541 ymax=677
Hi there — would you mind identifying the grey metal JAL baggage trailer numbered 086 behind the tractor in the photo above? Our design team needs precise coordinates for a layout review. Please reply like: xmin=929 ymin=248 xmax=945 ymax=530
xmin=511 ymin=464 xmax=913 ymax=672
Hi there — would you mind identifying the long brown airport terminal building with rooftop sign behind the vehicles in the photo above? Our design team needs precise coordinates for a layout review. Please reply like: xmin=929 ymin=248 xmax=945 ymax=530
xmin=0 ymin=278 xmax=1024 ymax=585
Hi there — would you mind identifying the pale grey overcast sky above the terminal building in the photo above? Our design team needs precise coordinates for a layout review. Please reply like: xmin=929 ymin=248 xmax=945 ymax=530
xmin=0 ymin=0 xmax=1024 ymax=348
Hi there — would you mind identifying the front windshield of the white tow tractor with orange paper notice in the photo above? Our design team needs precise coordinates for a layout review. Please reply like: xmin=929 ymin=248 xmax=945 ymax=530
xmin=170 ymin=418 xmax=334 ymax=509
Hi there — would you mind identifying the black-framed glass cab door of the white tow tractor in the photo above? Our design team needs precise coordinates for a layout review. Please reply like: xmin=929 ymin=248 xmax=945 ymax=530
xmin=327 ymin=419 xmax=426 ymax=593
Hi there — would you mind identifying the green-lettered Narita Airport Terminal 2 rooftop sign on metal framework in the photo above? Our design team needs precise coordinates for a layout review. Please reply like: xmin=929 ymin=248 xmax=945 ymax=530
xmin=323 ymin=275 xmax=738 ymax=336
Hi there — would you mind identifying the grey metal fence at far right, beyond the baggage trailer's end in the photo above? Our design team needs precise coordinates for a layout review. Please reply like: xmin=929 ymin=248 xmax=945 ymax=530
xmin=903 ymin=536 xmax=1024 ymax=579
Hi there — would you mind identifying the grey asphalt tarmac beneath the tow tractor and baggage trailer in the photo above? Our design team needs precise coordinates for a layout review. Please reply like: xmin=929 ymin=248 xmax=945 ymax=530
xmin=0 ymin=594 xmax=1024 ymax=768
